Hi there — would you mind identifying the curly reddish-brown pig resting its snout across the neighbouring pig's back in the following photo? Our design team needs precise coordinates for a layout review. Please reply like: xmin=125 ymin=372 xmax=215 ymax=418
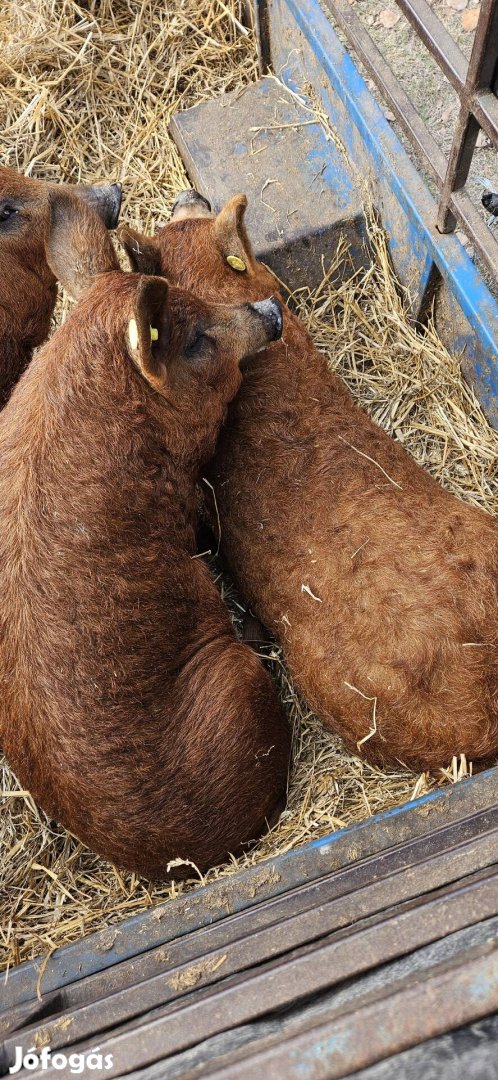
xmin=0 ymin=203 xmax=290 ymax=878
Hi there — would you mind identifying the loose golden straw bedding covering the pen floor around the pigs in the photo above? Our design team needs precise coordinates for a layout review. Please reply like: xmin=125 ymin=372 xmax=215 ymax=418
xmin=0 ymin=0 xmax=498 ymax=968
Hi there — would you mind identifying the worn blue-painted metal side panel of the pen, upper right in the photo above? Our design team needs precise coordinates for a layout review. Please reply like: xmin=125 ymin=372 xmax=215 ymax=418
xmin=270 ymin=0 xmax=498 ymax=427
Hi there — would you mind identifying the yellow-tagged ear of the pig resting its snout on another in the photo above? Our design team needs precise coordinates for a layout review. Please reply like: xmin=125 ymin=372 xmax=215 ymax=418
xmin=127 ymin=276 xmax=170 ymax=390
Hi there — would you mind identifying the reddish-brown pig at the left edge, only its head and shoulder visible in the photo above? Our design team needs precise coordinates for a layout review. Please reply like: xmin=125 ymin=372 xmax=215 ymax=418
xmin=0 ymin=166 xmax=121 ymax=408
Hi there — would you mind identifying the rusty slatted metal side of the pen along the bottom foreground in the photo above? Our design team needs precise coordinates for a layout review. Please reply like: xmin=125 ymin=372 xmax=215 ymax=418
xmin=0 ymin=770 xmax=498 ymax=1080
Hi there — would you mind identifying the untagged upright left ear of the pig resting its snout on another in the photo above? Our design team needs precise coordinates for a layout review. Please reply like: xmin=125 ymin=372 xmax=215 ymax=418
xmin=45 ymin=192 xmax=119 ymax=300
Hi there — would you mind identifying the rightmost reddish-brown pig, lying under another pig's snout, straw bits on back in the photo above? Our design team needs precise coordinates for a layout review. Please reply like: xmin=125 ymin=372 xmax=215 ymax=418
xmin=123 ymin=194 xmax=498 ymax=769
